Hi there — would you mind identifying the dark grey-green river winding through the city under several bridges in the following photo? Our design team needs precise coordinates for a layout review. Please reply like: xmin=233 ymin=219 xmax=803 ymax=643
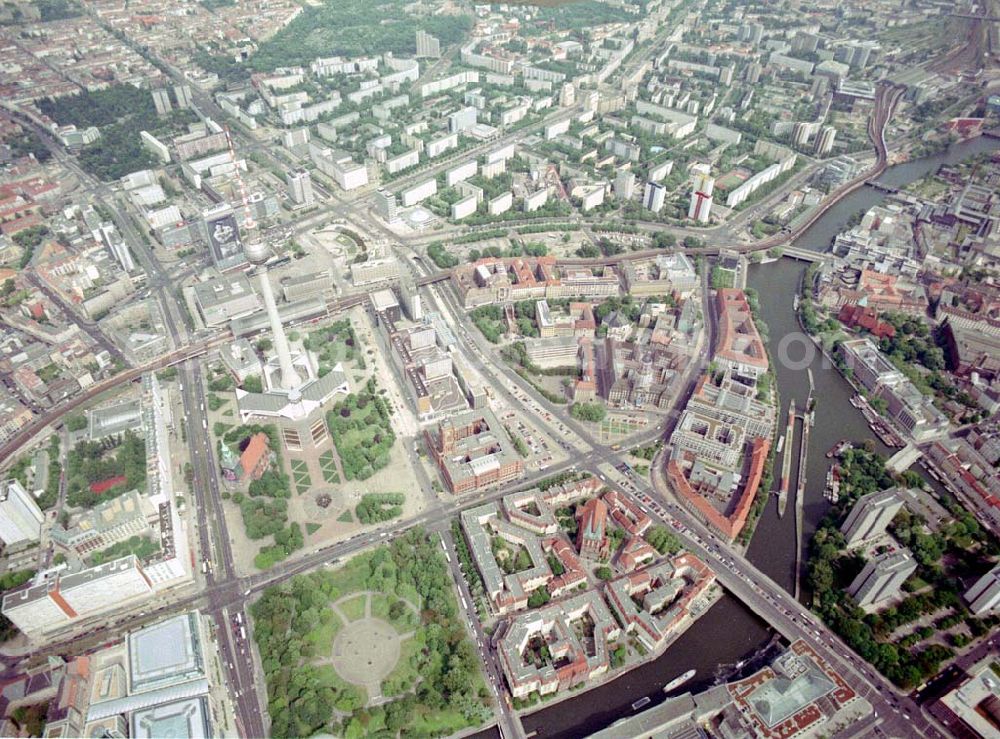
xmin=522 ymin=137 xmax=1000 ymax=739
